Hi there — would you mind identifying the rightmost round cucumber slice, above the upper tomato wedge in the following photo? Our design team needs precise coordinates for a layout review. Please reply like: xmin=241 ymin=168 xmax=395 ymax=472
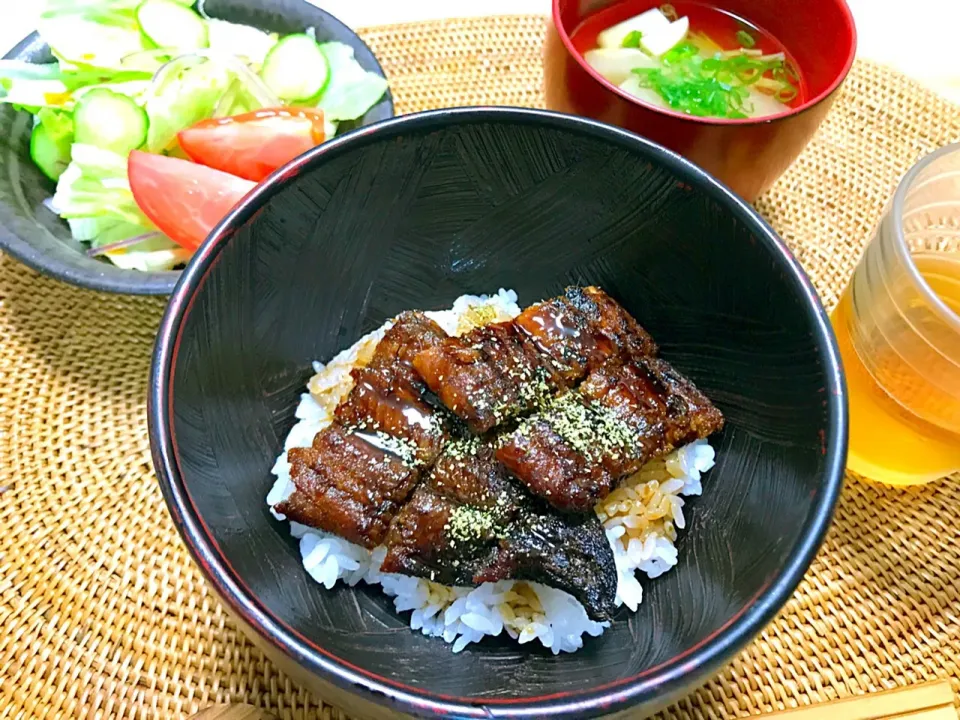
xmin=260 ymin=35 xmax=330 ymax=102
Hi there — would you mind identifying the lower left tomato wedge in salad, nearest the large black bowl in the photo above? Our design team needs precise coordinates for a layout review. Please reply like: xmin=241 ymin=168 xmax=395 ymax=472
xmin=127 ymin=150 xmax=257 ymax=250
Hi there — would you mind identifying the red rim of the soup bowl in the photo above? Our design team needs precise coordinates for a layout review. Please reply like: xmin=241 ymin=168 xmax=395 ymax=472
xmin=550 ymin=0 xmax=857 ymax=127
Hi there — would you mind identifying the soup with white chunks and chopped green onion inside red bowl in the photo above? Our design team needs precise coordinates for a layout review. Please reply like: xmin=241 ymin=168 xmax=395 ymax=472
xmin=571 ymin=0 xmax=806 ymax=119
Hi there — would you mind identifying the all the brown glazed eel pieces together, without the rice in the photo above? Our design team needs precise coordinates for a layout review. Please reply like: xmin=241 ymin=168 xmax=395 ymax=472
xmin=277 ymin=287 xmax=722 ymax=620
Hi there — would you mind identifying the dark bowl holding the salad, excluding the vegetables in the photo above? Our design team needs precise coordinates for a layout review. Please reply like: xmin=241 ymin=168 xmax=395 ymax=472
xmin=0 ymin=0 xmax=393 ymax=295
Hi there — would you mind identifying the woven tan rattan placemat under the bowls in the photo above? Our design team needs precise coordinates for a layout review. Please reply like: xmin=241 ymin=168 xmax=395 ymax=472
xmin=0 ymin=12 xmax=960 ymax=720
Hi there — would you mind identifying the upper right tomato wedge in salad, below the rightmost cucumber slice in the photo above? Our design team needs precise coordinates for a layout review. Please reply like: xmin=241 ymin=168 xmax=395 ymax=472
xmin=177 ymin=108 xmax=325 ymax=182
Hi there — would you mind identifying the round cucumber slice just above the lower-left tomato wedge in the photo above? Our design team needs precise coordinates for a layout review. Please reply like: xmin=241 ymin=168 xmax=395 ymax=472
xmin=73 ymin=89 xmax=150 ymax=155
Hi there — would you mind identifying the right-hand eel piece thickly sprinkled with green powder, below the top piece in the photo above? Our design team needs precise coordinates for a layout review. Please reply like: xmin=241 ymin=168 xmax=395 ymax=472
xmin=497 ymin=357 xmax=723 ymax=512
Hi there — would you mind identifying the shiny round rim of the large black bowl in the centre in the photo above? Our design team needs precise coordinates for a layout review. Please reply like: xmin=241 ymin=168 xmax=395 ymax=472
xmin=148 ymin=107 xmax=848 ymax=718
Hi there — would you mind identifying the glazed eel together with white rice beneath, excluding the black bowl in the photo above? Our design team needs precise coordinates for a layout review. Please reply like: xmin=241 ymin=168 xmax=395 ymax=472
xmin=266 ymin=288 xmax=723 ymax=653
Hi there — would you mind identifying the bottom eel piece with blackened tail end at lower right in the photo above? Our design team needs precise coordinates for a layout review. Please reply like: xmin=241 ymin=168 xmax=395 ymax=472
xmin=381 ymin=438 xmax=617 ymax=620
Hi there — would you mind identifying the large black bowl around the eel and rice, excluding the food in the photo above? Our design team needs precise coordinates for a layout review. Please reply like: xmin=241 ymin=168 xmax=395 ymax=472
xmin=149 ymin=108 xmax=847 ymax=718
